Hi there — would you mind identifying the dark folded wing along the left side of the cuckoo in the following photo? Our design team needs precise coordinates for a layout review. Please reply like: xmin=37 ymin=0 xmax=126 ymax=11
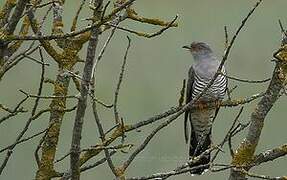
xmin=184 ymin=66 xmax=194 ymax=143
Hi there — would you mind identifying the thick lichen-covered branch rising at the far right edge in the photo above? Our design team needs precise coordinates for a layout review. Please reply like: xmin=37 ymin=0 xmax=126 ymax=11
xmin=229 ymin=16 xmax=286 ymax=180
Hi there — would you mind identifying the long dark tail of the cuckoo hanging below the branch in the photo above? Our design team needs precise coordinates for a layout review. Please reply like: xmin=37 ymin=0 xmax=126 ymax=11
xmin=189 ymin=125 xmax=211 ymax=175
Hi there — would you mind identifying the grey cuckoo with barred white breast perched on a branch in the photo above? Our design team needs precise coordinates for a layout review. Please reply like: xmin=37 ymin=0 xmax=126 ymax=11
xmin=183 ymin=42 xmax=227 ymax=174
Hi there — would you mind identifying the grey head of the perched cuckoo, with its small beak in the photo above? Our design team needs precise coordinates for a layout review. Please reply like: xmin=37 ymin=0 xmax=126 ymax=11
xmin=182 ymin=42 xmax=213 ymax=60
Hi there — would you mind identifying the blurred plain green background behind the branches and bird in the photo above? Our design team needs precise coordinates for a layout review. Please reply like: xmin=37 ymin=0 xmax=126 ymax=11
xmin=0 ymin=0 xmax=287 ymax=180
